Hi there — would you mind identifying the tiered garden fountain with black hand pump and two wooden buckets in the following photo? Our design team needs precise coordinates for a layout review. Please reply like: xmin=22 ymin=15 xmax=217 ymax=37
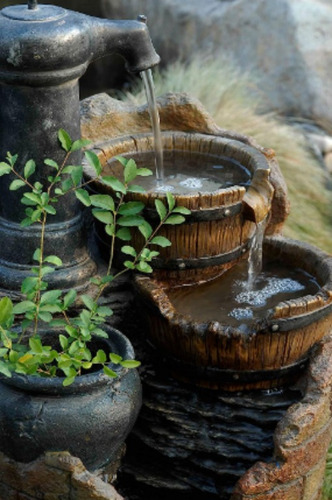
xmin=0 ymin=0 xmax=332 ymax=500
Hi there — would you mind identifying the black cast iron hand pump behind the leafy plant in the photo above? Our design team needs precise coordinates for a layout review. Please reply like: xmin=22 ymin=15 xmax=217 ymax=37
xmin=0 ymin=0 xmax=159 ymax=291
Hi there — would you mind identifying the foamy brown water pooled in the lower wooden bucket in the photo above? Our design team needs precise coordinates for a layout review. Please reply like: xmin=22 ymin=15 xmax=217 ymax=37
xmin=169 ymin=261 xmax=320 ymax=333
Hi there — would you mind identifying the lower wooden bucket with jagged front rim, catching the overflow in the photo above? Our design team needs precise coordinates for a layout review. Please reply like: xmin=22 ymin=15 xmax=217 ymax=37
xmin=136 ymin=237 xmax=332 ymax=391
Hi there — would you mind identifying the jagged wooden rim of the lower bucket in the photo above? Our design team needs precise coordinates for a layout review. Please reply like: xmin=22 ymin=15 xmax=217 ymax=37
xmin=135 ymin=236 xmax=332 ymax=338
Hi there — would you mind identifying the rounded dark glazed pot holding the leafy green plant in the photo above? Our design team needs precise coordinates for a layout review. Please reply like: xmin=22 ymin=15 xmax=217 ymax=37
xmin=0 ymin=328 xmax=141 ymax=470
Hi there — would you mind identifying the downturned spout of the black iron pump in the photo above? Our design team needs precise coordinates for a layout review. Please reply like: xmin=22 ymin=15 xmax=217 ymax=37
xmin=91 ymin=16 xmax=160 ymax=73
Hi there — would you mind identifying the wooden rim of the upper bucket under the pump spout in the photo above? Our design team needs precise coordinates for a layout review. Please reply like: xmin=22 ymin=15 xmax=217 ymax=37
xmin=84 ymin=131 xmax=270 ymax=210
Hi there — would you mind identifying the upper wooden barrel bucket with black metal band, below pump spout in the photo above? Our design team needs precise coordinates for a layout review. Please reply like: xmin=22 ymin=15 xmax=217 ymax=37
xmin=85 ymin=131 xmax=273 ymax=283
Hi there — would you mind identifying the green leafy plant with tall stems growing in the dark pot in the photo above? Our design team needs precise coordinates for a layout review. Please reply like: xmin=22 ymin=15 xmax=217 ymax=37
xmin=0 ymin=130 xmax=190 ymax=386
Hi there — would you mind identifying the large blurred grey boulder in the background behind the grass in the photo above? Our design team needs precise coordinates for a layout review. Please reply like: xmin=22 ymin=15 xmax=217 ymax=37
xmin=101 ymin=0 xmax=332 ymax=127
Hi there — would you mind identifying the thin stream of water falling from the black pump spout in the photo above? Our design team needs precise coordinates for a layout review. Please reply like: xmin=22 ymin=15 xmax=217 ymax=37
xmin=141 ymin=69 xmax=164 ymax=187
